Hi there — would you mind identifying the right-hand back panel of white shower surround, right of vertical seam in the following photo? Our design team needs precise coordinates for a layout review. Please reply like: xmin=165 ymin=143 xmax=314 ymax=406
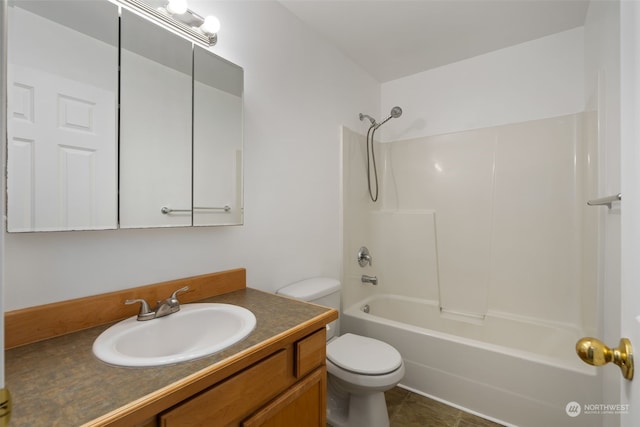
xmin=489 ymin=115 xmax=596 ymax=323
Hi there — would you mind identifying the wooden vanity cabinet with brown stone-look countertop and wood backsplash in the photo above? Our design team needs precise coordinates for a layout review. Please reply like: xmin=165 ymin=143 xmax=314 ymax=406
xmin=5 ymin=268 xmax=338 ymax=427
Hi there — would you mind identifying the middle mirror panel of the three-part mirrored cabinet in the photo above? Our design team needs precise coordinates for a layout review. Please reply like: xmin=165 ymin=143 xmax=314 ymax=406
xmin=120 ymin=10 xmax=192 ymax=228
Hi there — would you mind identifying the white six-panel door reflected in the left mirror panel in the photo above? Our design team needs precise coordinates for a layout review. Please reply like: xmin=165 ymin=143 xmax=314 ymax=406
xmin=7 ymin=64 xmax=117 ymax=231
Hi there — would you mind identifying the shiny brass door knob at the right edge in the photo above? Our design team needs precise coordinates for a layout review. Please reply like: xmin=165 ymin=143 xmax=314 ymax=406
xmin=576 ymin=337 xmax=633 ymax=380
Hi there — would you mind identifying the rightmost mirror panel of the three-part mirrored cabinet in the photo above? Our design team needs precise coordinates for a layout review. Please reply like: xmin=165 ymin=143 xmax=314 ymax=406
xmin=193 ymin=46 xmax=244 ymax=225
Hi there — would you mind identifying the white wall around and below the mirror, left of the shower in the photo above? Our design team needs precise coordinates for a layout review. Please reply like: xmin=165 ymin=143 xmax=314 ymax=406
xmin=5 ymin=1 xmax=380 ymax=310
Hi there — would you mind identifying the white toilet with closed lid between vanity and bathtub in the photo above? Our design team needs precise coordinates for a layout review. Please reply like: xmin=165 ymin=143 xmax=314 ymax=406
xmin=277 ymin=277 xmax=404 ymax=427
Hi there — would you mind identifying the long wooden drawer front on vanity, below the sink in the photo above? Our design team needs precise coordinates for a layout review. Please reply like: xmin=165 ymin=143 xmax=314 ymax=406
xmin=160 ymin=350 xmax=292 ymax=427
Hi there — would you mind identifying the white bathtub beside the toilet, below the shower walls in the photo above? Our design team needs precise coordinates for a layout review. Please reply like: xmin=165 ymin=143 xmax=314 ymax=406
xmin=341 ymin=294 xmax=603 ymax=427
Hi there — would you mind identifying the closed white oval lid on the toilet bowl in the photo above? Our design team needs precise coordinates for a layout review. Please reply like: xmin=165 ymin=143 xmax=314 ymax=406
xmin=327 ymin=334 xmax=402 ymax=375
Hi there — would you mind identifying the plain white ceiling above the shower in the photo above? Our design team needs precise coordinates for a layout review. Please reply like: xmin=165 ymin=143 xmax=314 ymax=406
xmin=281 ymin=0 xmax=589 ymax=82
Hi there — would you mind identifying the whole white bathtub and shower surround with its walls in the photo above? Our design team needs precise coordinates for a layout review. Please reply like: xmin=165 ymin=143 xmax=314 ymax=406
xmin=343 ymin=109 xmax=602 ymax=427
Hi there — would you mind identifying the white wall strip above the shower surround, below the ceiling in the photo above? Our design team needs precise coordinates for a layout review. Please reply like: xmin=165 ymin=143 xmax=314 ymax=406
xmin=380 ymin=28 xmax=584 ymax=141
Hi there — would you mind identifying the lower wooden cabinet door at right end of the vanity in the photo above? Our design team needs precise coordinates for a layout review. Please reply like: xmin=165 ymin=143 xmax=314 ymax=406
xmin=242 ymin=366 xmax=327 ymax=427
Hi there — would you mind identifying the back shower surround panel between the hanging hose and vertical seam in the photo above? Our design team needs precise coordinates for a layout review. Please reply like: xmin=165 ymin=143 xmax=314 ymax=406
xmin=390 ymin=130 xmax=496 ymax=315
